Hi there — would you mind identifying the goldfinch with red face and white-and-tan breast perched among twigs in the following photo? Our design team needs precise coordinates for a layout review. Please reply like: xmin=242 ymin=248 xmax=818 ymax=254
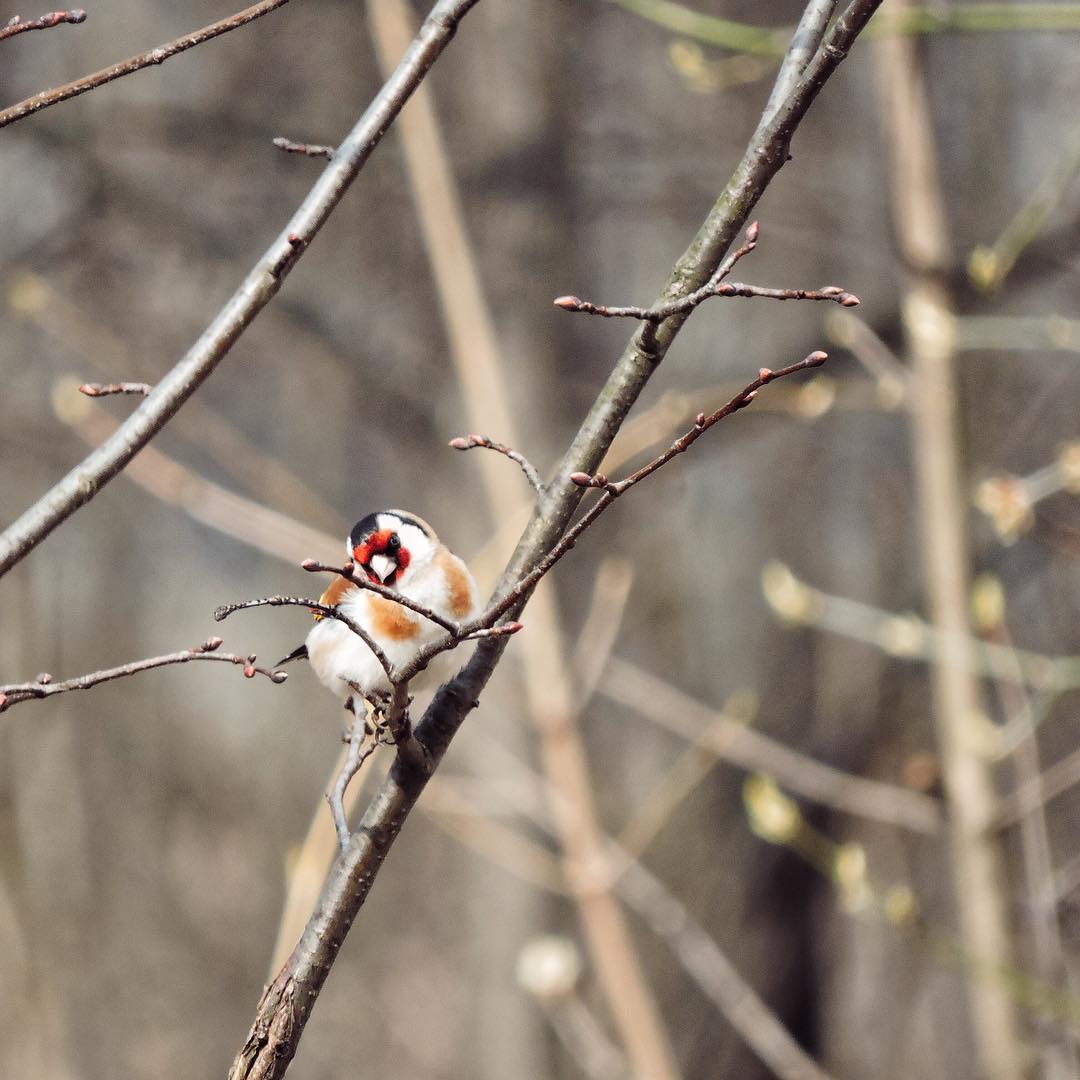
xmin=279 ymin=510 xmax=480 ymax=711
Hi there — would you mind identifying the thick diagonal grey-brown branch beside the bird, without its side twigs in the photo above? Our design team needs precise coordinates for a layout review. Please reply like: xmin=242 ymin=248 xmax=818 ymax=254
xmin=230 ymin=0 xmax=880 ymax=1080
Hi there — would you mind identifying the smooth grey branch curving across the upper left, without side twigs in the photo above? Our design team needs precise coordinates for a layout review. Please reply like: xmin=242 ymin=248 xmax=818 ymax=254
xmin=0 ymin=0 xmax=476 ymax=575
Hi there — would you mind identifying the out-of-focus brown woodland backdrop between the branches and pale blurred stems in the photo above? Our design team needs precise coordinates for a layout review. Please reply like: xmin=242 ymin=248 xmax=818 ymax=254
xmin=0 ymin=0 xmax=1080 ymax=1080
